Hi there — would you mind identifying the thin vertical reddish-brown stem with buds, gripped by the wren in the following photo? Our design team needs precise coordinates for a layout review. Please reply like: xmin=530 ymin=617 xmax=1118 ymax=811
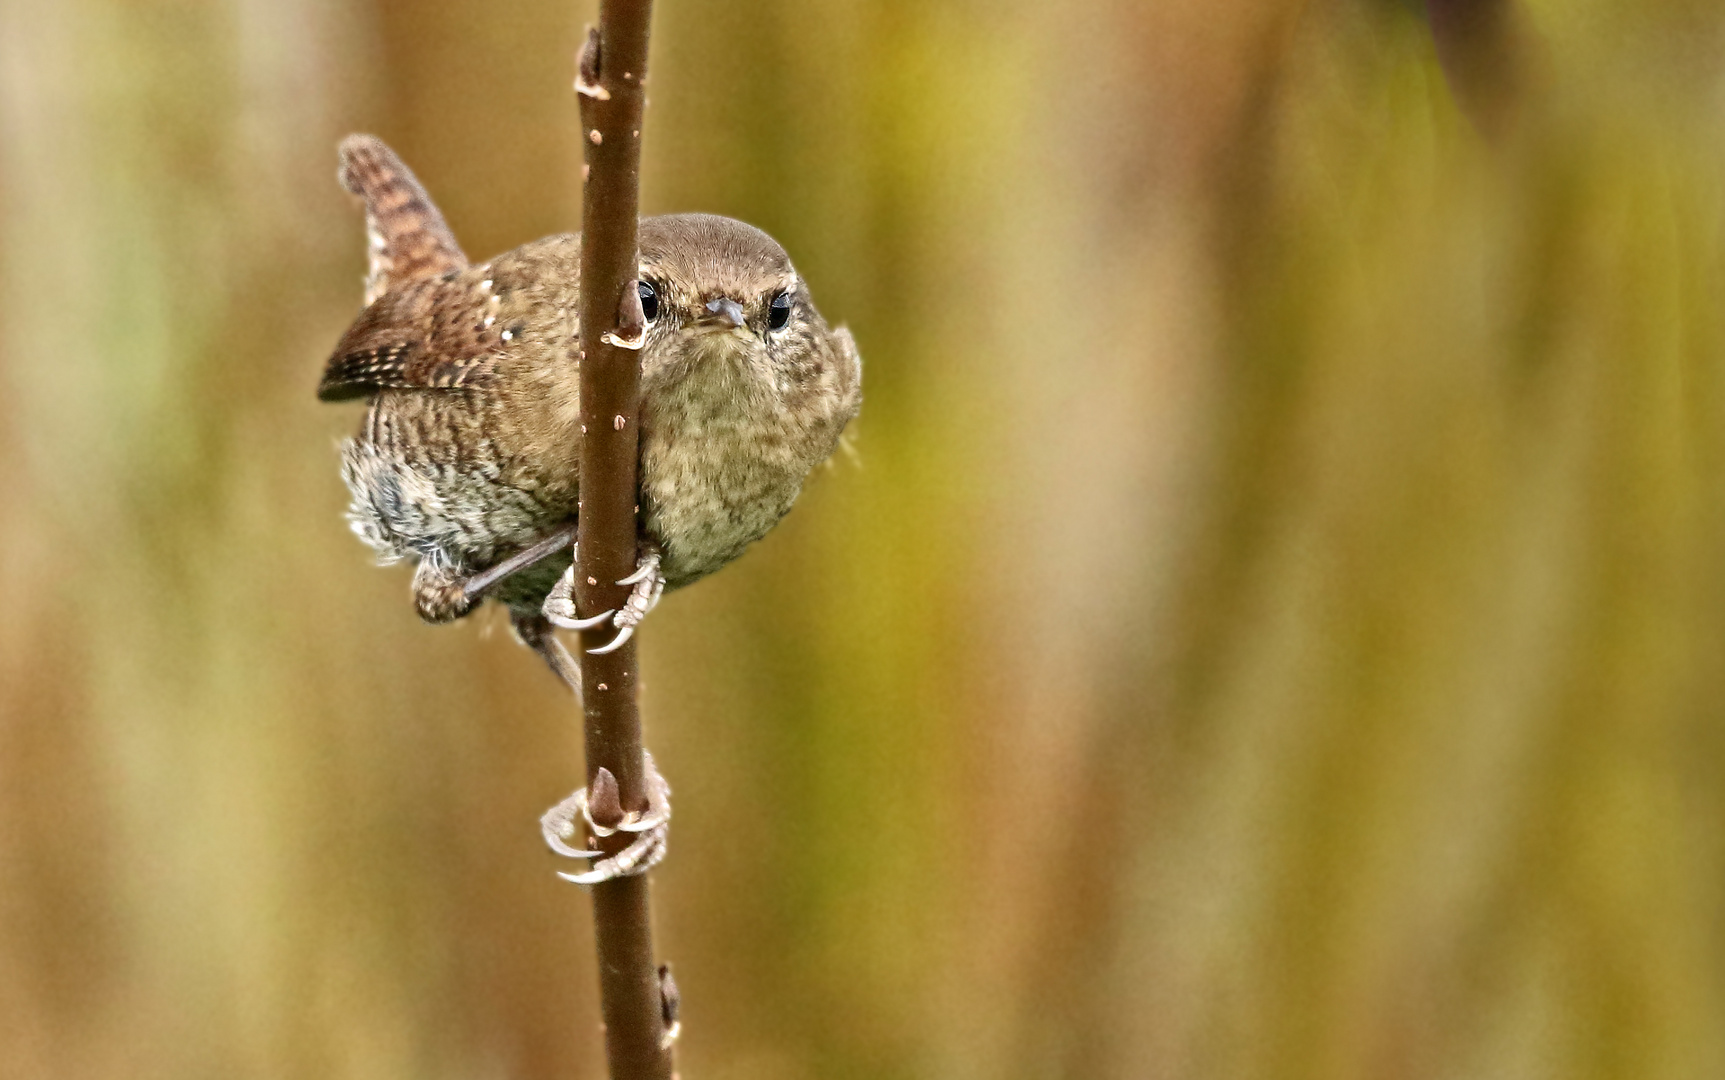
xmin=574 ymin=0 xmax=671 ymax=1080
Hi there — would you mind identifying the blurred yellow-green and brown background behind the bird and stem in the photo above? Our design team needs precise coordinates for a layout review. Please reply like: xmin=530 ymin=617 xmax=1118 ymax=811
xmin=0 ymin=0 xmax=1725 ymax=1080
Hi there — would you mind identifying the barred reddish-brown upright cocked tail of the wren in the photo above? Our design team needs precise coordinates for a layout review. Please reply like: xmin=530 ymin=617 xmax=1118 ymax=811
xmin=340 ymin=135 xmax=467 ymax=305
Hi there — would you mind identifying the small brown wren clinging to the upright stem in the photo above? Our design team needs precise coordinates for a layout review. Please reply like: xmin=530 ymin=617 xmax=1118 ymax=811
xmin=317 ymin=135 xmax=863 ymax=672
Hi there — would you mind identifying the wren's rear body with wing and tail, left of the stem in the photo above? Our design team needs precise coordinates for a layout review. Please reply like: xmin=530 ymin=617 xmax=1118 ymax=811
xmin=319 ymin=136 xmax=580 ymax=599
